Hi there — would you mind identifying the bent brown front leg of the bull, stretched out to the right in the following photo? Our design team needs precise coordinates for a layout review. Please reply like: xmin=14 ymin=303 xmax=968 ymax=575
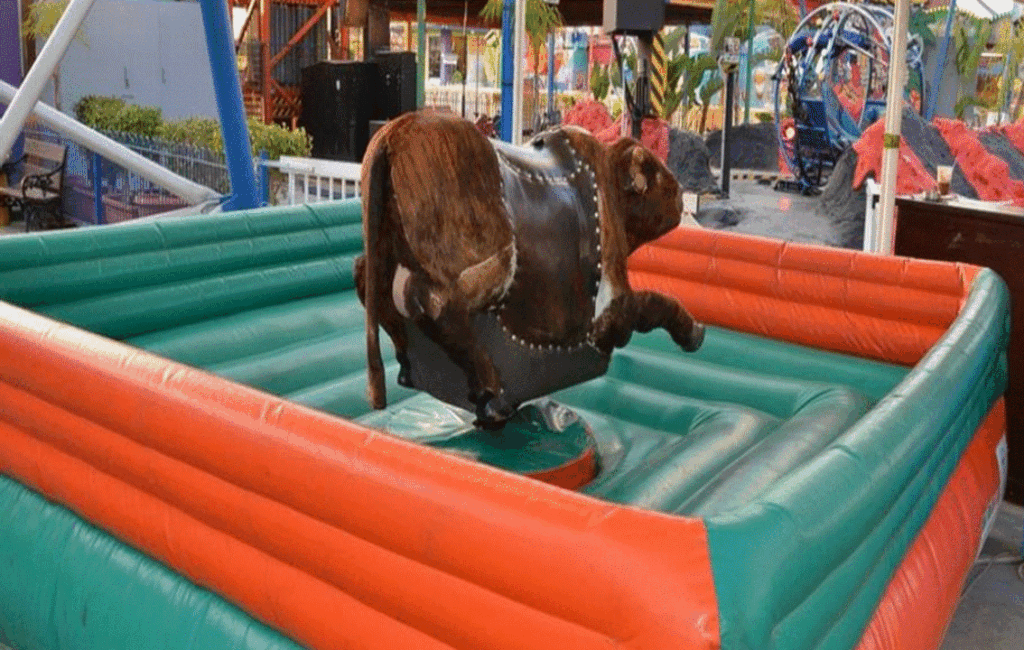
xmin=593 ymin=291 xmax=705 ymax=354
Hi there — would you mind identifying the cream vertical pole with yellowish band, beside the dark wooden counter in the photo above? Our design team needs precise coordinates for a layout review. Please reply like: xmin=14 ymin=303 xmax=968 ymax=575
xmin=874 ymin=0 xmax=909 ymax=255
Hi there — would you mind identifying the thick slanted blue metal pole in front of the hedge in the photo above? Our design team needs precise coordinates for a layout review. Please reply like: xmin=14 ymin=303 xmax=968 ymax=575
xmin=200 ymin=0 xmax=260 ymax=211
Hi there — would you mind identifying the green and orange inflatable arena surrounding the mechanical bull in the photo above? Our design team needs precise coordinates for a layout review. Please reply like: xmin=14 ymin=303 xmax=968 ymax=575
xmin=0 ymin=202 xmax=1009 ymax=650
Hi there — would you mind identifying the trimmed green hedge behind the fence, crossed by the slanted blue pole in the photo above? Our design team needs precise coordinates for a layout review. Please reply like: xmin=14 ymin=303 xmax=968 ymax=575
xmin=75 ymin=95 xmax=312 ymax=160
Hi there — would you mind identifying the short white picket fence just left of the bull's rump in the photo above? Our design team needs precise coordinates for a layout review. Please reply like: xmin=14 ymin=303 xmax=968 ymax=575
xmin=261 ymin=156 xmax=360 ymax=206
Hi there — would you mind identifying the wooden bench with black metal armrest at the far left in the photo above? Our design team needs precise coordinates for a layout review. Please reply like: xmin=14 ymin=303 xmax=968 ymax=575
xmin=0 ymin=137 xmax=75 ymax=231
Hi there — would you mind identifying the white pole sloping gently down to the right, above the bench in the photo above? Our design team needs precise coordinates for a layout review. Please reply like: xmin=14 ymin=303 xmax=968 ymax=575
xmin=0 ymin=81 xmax=220 ymax=203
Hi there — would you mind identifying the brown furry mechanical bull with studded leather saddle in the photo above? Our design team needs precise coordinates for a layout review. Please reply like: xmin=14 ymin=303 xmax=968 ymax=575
xmin=355 ymin=112 xmax=703 ymax=428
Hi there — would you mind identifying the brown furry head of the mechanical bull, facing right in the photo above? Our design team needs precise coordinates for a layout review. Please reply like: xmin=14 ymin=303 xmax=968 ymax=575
xmin=608 ymin=138 xmax=683 ymax=253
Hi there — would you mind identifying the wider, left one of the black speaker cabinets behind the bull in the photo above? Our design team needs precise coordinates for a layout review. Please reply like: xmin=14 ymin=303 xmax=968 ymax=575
xmin=299 ymin=61 xmax=380 ymax=163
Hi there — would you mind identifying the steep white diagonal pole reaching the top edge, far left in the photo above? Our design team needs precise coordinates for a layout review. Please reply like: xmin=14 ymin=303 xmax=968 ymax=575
xmin=0 ymin=0 xmax=93 ymax=162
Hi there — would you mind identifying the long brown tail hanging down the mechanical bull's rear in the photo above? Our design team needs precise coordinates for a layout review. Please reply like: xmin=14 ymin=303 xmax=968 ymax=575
xmin=362 ymin=138 xmax=390 ymax=408
